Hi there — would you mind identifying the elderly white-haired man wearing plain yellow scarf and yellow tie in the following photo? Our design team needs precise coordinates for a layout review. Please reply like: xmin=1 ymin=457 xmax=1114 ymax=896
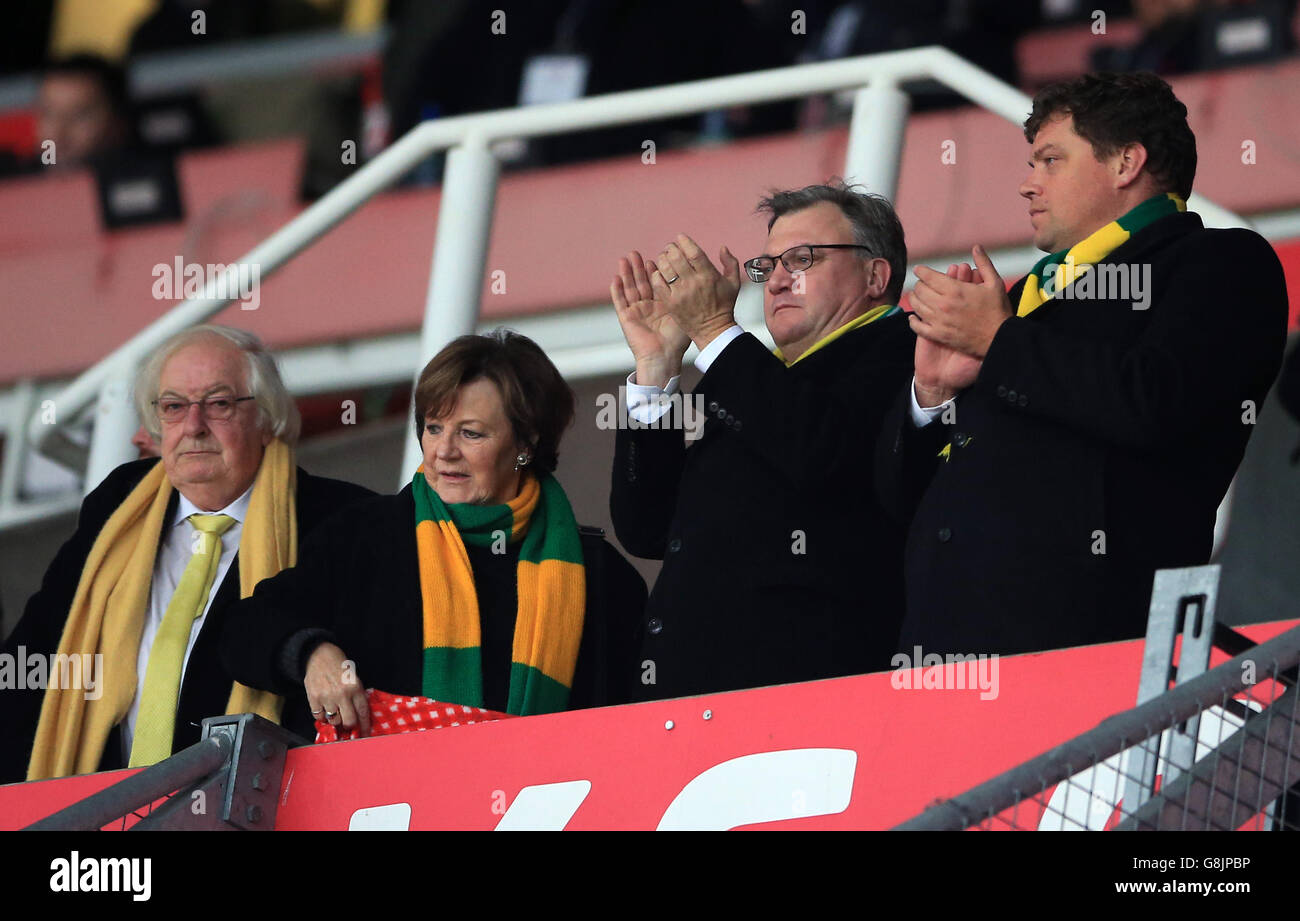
xmin=0 ymin=325 xmax=371 ymax=783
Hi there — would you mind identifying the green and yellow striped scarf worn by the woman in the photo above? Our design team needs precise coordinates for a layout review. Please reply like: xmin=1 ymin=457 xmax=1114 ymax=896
xmin=411 ymin=467 xmax=586 ymax=715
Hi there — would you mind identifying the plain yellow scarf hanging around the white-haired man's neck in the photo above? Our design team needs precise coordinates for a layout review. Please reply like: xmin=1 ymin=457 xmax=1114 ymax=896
xmin=27 ymin=438 xmax=298 ymax=781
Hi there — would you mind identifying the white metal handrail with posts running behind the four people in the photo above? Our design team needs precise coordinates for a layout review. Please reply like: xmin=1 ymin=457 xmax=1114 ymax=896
xmin=15 ymin=47 xmax=1247 ymax=522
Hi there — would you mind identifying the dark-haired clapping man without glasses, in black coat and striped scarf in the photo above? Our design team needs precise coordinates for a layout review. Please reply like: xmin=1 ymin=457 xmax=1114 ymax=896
xmin=878 ymin=74 xmax=1287 ymax=665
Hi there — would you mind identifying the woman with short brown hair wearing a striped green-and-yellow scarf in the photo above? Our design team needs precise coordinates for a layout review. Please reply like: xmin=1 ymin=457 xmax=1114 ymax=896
xmin=222 ymin=330 xmax=646 ymax=735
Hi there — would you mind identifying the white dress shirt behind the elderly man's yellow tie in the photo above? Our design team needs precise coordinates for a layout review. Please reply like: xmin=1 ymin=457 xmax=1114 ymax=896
xmin=122 ymin=487 xmax=252 ymax=764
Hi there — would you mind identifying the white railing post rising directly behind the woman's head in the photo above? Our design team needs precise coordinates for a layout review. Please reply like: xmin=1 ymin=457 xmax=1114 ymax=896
xmin=398 ymin=135 xmax=501 ymax=485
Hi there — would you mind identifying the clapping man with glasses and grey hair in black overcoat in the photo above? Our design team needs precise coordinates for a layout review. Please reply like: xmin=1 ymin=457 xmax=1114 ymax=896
xmin=611 ymin=185 xmax=914 ymax=699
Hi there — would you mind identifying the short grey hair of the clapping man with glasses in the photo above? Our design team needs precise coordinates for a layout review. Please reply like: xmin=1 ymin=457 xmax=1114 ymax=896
xmin=757 ymin=178 xmax=907 ymax=303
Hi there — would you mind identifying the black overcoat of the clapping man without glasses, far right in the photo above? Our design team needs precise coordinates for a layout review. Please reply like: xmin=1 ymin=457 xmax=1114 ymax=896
xmin=876 ymin=213 xmax=1287 ymax=654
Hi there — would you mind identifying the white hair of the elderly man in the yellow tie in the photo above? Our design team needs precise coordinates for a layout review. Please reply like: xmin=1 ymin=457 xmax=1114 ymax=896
xmin=135 ymin=324 xmax=303 ymax=445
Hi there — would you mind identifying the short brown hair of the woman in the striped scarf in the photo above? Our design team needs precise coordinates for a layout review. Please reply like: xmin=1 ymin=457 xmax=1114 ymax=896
xmin=415 ymin=328 xmax=575 ymax=474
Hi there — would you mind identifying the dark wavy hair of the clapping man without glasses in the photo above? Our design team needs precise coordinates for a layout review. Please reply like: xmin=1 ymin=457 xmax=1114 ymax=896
xmin=1024 ymin=73 xmax=1196 ymax=199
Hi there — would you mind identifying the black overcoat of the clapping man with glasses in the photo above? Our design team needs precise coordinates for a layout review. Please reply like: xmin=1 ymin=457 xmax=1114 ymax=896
xmin=610 ymin=315 xmax=915 ymax=699
